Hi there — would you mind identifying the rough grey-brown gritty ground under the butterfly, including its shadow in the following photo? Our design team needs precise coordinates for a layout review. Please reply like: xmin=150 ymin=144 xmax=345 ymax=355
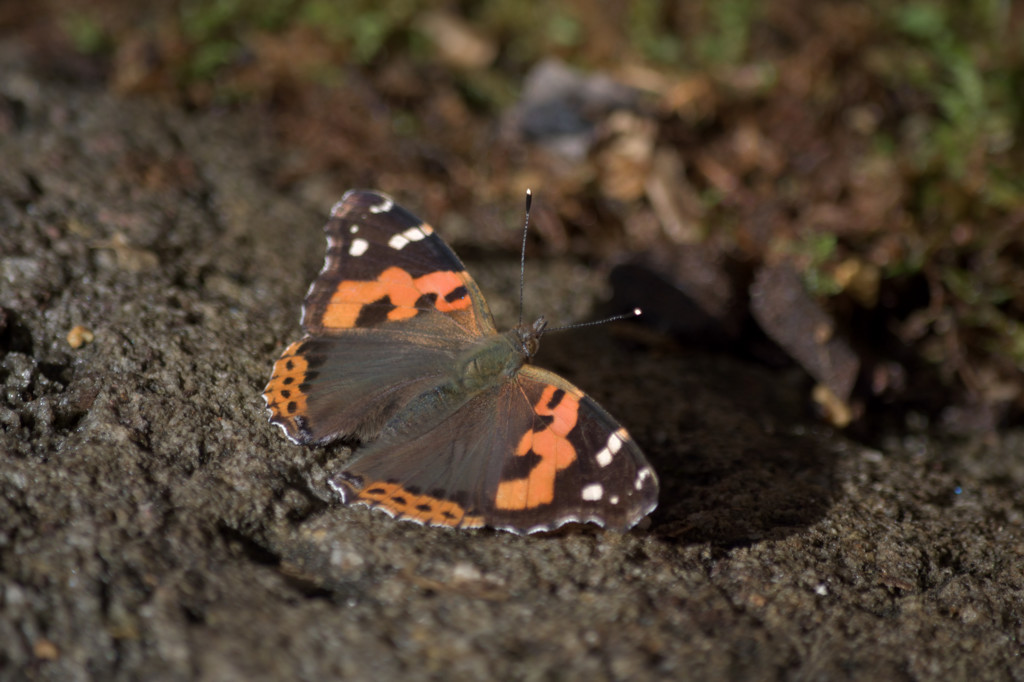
xmin=0 ymin=41 xmax=1024 ymax=680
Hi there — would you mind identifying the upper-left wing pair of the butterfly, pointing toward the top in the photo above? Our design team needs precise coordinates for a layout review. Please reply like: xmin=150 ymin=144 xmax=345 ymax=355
xmin=263 ymin=190 xmax=495 ymax=443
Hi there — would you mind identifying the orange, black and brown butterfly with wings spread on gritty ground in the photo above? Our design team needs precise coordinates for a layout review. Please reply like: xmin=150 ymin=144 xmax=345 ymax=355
xmin=263 ymin=189 xmax=658 ymax=534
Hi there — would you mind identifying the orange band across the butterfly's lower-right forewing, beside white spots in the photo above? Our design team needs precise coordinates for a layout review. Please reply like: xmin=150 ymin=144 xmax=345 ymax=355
xmin=495 ymin=385 xmax=580 ymax=510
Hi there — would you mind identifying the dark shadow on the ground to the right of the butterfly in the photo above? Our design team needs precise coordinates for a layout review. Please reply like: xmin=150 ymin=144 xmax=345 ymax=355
xmin=542 ymin=324 xmax=838 ymax=549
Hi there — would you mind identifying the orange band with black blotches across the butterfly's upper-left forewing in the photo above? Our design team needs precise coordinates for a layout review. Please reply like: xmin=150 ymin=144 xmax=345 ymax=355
xmin=323 ymin=267 xmax=472 ymax=329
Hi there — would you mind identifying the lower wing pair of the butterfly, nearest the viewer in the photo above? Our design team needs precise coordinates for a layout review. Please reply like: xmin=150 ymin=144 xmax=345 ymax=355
xmin=331 ymin=366 xmax=657 ymax=532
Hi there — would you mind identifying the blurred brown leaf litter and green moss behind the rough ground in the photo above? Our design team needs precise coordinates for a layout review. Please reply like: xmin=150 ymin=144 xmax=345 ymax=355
xmin=16 ymin=0 xmax=1024 ymax=431
